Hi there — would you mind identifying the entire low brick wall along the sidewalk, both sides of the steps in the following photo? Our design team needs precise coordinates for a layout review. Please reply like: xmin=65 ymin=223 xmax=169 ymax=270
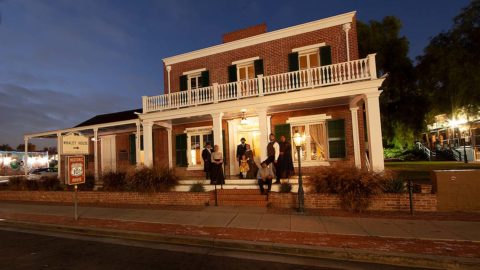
xmin=0 ymin=191 xmax=437 ymax=211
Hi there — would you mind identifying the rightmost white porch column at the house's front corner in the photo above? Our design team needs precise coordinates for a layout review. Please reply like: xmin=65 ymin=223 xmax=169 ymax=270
xmin=365 ymin=91 xmax=384 ymax=171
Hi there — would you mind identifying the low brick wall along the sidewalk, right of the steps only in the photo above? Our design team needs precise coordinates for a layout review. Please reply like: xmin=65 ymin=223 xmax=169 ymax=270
xmin=269 ymin=193 xmax=437 ymax=211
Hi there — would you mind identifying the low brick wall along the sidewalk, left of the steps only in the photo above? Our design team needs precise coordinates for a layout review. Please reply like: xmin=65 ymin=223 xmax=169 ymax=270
xmin=0 ymin=191 xmax=210 ymax=205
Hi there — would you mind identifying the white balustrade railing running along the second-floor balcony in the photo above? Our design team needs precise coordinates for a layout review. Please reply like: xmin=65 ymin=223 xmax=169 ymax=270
xmin=142 ymin=54 xmax=377 ymax=113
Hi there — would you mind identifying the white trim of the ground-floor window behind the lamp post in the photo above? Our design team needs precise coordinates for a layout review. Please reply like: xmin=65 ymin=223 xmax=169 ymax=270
xmin=286 ymin=114 xmax=332 ymax=167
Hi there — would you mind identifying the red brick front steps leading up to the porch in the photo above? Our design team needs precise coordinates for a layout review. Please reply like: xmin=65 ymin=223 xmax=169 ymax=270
xmin=210 ymin=187 xmax=268 ymax=207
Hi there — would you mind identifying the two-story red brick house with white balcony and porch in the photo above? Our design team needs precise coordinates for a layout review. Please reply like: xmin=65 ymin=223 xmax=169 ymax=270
xmin=26 ymin=12 xmax=384 ymax=182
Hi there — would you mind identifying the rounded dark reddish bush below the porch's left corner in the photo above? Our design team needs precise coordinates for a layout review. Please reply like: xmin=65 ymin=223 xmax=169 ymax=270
xmin=127 ymin=167 xmax=178 ymax=192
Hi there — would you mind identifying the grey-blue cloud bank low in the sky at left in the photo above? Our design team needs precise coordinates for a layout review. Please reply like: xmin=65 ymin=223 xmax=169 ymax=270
xmin=0 ymin=83 xmax=133 ymax=146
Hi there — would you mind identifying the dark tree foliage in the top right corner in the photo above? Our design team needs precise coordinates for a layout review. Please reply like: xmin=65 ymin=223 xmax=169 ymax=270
xmin=417 ymin=0 xmax=480 ymax=116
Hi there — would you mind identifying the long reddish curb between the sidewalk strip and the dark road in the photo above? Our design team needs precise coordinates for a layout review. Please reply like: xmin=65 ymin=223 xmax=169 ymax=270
xmin=0 ymin=220 xmax=480 ymax=269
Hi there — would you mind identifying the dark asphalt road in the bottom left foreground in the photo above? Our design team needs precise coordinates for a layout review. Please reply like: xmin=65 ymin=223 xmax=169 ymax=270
xmin=0 ymin=229 xmax=428 ymax=270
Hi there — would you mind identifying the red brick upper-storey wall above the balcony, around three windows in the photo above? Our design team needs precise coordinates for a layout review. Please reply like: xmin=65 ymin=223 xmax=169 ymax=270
xmin=164 ymin=17 xmax=358 ymax=93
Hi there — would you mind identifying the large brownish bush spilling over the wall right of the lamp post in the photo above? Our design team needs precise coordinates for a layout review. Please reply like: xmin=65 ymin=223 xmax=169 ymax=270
xmin=306 ymin=165 xmax=387 ymax=212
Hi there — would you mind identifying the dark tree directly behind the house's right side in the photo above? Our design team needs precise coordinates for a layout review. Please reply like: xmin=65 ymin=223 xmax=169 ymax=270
xmin=357 ymin=16 xmax=426 ymax=147
